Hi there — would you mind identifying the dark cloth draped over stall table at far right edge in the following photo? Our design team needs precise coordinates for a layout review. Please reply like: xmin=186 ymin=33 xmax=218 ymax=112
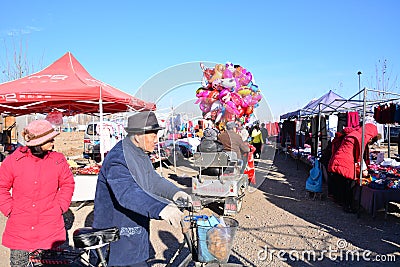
xmin=360 ymin=186 xmax=400 ymax=218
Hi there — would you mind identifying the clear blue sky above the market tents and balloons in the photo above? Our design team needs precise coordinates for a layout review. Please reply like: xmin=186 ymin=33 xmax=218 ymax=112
xmin=0 ymin=0 xmax=400 ymax=120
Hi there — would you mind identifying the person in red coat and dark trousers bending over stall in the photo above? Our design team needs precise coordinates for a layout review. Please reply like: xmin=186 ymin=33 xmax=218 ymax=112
xmin=328 ymin=123 xmax=378 ymax=212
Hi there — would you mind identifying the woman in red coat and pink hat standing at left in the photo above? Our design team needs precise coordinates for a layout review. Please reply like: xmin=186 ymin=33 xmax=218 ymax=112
xmin=0 ymin=120 xmax=75 ymax=267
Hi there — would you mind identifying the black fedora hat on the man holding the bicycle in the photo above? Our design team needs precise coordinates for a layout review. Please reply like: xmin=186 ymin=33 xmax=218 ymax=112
xmin=125 ymin=111 xmax=164 ymax=133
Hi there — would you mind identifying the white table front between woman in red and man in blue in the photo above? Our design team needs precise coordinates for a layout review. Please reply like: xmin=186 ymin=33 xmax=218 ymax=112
xmin=72 ymin=174 xmax=97 ymax=202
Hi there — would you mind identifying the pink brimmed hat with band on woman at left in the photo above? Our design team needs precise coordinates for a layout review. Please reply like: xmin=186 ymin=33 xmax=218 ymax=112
xmin=22 ymin=120 xmax=60 ymax=146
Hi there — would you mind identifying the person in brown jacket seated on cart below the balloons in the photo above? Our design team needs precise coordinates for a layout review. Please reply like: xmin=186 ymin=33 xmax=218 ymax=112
xmin=218 ymin=121 xmax=250 ymax=165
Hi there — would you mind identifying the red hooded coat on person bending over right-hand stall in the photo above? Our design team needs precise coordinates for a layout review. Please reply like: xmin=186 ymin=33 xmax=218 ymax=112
xmin=328 ymin=123 xmax=378 ymax=180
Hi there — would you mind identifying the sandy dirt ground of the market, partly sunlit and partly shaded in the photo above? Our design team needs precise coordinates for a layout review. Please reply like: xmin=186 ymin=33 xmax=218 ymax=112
xmin=0 ymin=134 xmax=400 ymax=267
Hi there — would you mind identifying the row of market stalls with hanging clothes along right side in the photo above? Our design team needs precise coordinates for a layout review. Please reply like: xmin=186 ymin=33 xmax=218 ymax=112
xmin=281 ymin=88 xmax=400 ymax=216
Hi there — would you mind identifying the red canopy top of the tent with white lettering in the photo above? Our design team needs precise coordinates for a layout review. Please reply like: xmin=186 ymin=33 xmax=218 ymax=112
xmin=0 ymin=52 xmax=156 ymax=115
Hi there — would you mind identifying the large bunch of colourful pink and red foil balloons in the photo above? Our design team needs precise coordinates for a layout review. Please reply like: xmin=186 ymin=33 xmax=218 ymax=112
xmin=196 ymin=62 xmax=261 ymax=127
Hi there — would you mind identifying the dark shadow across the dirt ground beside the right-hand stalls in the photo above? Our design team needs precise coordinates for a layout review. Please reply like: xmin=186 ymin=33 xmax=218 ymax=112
xmin=257 ymin=148 xmax=400 ymax=266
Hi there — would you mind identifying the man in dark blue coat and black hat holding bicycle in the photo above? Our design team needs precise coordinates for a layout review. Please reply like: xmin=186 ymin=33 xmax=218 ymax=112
xmin=91 ymin=111 xmax=191 ymax=266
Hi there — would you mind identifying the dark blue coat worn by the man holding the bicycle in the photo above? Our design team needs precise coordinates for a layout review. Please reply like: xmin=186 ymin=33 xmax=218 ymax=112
xmin=93 ymin=137 xmax=180 ymax=266
